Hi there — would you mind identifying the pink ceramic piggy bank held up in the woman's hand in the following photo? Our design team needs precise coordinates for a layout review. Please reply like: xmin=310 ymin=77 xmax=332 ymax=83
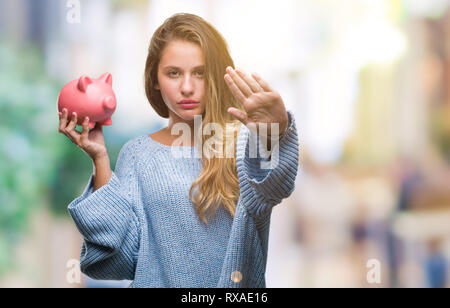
xmin=58 ymin=73 xmax=116 ymax=128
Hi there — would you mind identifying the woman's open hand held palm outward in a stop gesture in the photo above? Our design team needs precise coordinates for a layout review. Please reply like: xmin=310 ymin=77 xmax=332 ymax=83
xmin=224 ymin=66 xmax=288 ymax=138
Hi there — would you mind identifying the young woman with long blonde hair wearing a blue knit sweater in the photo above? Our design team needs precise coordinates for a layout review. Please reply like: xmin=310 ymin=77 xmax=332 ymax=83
xmin=59 ymin=14 xmax=298 ymax=287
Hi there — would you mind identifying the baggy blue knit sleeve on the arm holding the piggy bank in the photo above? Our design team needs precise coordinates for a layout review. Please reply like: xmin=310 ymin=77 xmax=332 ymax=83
xmin=68 ymin=141 xmax=141 ymax=280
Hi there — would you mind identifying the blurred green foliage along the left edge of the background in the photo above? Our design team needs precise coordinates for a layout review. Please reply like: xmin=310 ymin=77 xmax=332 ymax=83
xmin=0 ymin=42 xmax=71 ymax=275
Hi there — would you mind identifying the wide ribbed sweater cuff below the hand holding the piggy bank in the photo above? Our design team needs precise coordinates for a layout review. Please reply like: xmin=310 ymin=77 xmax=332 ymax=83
xmin=68 ymin=172 xmax=132 ymax=251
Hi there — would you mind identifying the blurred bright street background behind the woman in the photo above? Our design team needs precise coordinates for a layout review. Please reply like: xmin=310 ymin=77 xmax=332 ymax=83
xmin=0 ymin=0 xmax=450 ymax=288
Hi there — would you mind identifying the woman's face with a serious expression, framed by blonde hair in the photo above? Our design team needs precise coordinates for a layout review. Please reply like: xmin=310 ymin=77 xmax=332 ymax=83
xmin=155 ymin=40 xmax=205 ymax=122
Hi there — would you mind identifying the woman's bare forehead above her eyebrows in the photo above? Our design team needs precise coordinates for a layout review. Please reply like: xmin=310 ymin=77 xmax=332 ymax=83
xmin=160 ymin=40 xmax=204 ymax=68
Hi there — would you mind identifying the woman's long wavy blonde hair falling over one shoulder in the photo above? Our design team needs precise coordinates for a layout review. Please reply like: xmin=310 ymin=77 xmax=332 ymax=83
xmin=144 ymin=13 xmax=243 ymax=224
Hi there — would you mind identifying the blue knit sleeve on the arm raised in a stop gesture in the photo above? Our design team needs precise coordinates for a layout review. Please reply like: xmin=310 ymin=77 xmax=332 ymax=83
xmin=236 ymin=110 xmax=299 ymax=217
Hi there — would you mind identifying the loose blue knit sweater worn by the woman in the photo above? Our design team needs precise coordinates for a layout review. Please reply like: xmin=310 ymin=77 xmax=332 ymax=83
xmin=68 ymin=111 xmax=299 ymax=288
